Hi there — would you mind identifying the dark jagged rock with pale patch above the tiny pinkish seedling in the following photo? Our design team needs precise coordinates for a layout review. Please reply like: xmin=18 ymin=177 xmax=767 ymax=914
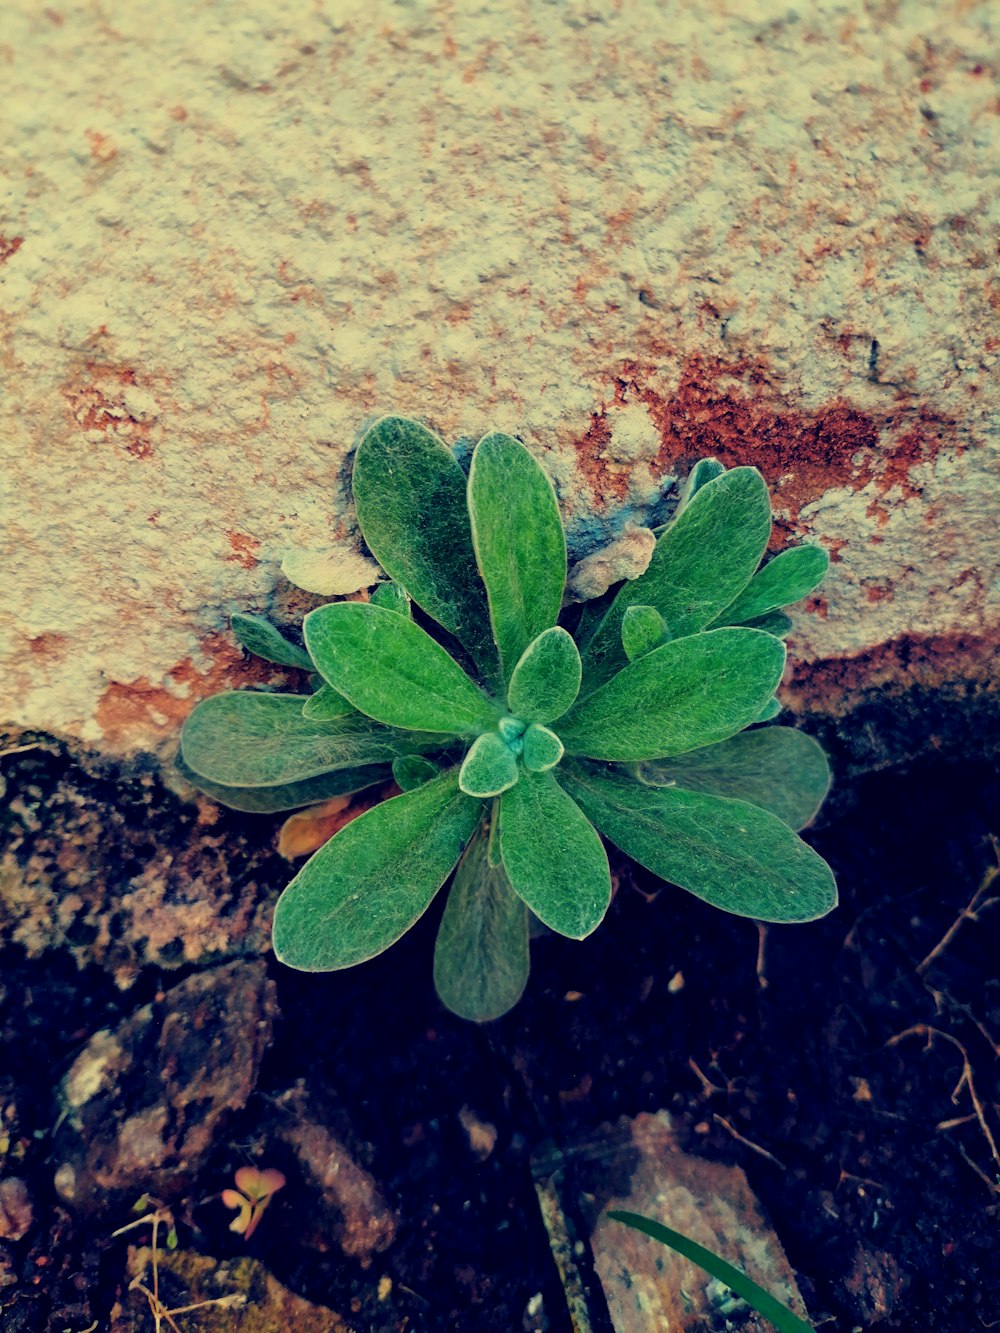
xmin=55 ymin=962 xmax=275 ymax=1213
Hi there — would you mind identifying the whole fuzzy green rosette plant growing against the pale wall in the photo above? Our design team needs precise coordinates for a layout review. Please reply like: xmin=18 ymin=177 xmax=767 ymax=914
xmin=181 ymin=417 xmax=836 ymax=1020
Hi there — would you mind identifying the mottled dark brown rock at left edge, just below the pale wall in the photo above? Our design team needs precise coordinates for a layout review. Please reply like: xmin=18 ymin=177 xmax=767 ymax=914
xmin=0 ymin=749 xmax=278 ymax=989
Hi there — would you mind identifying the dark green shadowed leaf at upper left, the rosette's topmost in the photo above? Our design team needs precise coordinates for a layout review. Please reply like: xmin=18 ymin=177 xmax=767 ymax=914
xmin=353 ymin=416 xmax=500 ymax=681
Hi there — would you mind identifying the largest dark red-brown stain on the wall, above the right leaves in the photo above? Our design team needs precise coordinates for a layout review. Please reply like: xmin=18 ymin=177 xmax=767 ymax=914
xmin=577 ymin=355 xmax=961 ymax=541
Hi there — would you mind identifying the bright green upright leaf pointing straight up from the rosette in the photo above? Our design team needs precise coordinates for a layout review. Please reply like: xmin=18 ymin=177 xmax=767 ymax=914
xmin=468 ymin=433 xmax=565 ymax=680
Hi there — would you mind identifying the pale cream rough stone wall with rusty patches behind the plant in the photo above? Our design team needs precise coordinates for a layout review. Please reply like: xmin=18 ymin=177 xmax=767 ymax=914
xmin=0 ymin=0 xmax=1000 ymax=754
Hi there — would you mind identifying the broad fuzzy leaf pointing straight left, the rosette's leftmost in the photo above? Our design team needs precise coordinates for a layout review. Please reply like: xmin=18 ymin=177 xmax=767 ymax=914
xmin=181 ymin=690 xmax=441 ymax=786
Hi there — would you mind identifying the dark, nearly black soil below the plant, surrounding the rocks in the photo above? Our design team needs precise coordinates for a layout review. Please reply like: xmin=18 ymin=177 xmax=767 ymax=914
xmin=0 ymin=754 xmax=1000 ymax=1333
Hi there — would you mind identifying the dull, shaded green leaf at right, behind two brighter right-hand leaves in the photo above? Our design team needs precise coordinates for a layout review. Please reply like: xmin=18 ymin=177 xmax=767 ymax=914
xmin=636 ymin=726 xmax=829 ymax=829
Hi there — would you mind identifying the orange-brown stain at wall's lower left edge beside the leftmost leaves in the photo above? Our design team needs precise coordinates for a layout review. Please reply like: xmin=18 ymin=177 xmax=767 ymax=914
xmin=95 ymin=635 xmax=293 ymax=748
